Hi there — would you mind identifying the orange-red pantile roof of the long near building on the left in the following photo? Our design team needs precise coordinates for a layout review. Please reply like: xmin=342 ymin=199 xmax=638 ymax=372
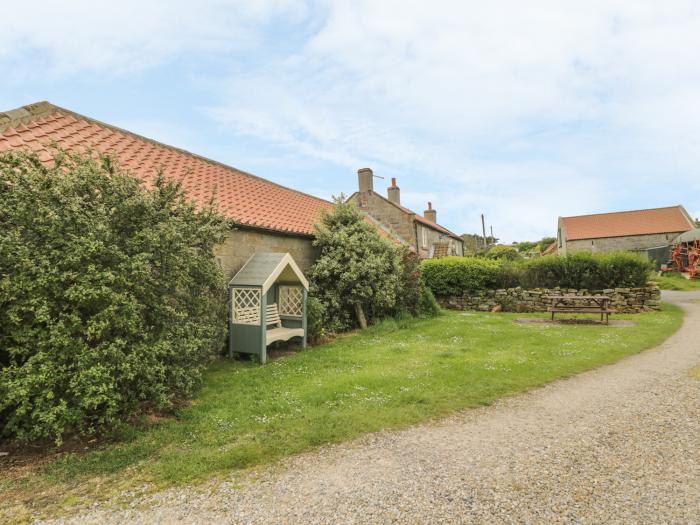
xmin=0 ymin=102 xmax=332 ymax=236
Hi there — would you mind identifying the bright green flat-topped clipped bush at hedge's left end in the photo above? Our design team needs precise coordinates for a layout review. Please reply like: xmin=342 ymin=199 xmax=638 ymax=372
xmin=422 ymin=257 xmax=500 ymax=297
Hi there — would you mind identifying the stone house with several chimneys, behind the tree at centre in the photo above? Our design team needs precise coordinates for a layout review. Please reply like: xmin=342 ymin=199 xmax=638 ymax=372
xmin=348 ymin=168 xmax=464 ymax=259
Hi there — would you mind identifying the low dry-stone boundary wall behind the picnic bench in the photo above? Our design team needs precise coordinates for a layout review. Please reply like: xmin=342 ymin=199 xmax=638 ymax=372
xmin=437 ymin=285 xmax=661 ymax=313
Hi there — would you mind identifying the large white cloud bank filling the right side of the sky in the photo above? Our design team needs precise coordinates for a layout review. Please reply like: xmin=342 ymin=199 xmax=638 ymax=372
xmin=209 ymin=0 xmax=700 ymax=239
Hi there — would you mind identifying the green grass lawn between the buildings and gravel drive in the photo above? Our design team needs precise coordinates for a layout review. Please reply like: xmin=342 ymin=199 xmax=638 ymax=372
xmin=0 ymin=305 xmax=682 ymax=521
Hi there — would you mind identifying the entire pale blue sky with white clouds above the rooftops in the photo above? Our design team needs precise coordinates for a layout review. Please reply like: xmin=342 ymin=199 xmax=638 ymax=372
xmin=0 ymin=0 xmax=700 ymax=242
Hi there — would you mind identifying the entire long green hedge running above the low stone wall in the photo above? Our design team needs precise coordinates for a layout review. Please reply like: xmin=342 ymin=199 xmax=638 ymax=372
xmin=423 ymin=252 xmax=652 ymax=297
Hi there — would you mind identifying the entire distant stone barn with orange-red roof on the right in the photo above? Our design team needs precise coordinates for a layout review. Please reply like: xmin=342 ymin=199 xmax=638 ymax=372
xmin=557 ymin=205 xmax=695 ymax=255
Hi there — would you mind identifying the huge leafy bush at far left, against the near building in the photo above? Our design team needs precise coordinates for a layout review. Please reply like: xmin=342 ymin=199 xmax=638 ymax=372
xmin=0 ymin=151 xmax=227 ymax=441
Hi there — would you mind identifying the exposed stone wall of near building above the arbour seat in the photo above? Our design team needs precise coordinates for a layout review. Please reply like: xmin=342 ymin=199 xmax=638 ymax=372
xmin=214 ymin=228 xmax=319 ymax=283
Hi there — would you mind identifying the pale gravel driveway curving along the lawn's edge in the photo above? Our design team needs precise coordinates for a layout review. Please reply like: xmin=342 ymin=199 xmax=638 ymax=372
xmin=46 ymin=294 xmax=700 ymax=525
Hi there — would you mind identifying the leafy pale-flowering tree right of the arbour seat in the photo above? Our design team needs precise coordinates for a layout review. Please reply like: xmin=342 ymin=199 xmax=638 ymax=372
xmin=310 ymin=199 xmax=402 ymax=331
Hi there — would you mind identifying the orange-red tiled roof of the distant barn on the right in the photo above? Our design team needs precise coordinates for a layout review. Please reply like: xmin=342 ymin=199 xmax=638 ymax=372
xmin=562 ymin=206 xmax=695 ymax=241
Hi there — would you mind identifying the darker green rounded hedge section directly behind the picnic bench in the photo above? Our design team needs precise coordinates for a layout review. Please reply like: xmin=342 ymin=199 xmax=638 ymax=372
xmin=522 ymin=252 xmax=653 ymax=290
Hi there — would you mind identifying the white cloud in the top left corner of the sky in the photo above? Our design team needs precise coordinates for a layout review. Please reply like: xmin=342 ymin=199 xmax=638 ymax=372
xmin=0 ymin=0 xmax=306 ymax=77
